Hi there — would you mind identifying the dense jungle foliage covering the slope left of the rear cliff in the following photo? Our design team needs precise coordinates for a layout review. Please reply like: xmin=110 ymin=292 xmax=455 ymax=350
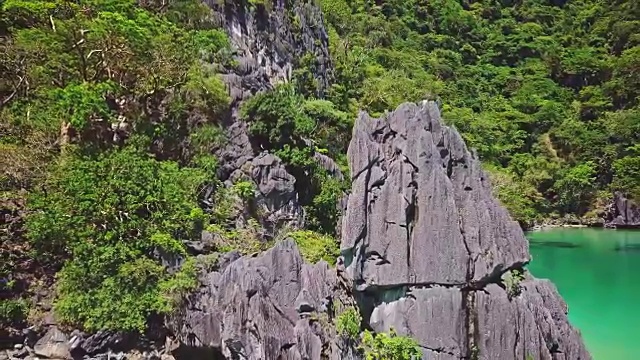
xmin=0 ymin=0 xmax=238 ymax=331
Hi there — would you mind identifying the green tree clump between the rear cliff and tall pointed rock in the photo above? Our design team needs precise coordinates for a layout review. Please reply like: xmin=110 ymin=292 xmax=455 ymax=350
xmin=242 ymin=85 xmax=351 ymax=234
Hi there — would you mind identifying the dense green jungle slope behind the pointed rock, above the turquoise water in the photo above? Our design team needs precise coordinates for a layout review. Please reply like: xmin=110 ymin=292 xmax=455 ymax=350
xmin=322 ymin=0 xmax=640 ymax=226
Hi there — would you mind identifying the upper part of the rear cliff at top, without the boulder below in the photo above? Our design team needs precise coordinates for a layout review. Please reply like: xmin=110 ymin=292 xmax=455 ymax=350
xmin=205 ymin=0 xmax=331 ymax=179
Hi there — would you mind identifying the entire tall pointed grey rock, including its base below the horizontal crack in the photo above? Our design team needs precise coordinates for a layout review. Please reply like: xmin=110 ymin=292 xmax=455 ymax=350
xmin=342 ymin=102 xmax=590 ymax=359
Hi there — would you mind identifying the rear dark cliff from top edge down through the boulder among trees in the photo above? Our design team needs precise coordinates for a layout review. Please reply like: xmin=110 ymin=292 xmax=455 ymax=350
xmin=205 ymin=0 xmax=332 ymax=228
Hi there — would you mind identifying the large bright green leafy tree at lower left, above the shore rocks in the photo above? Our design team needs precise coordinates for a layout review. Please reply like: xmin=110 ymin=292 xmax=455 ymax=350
xmin=27 ymin=148 xmax=208 ymax=331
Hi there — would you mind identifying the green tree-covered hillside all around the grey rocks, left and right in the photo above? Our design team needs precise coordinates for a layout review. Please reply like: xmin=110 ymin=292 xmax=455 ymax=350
xmin=0 ymin=0 xmax=640 ymax=352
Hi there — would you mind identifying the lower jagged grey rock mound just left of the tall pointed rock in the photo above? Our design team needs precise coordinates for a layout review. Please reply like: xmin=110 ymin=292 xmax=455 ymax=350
xmin=168 ymin=240 xmax=335 ymax=360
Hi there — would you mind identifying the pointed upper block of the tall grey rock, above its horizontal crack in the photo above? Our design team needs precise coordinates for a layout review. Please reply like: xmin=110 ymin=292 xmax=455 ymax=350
xmin=342 ymin=103 xmax=529 ymax=287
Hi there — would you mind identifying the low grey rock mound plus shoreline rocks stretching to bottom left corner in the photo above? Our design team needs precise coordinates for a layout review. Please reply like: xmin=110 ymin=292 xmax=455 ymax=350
xmin=0 ymin=239 xmax=342 ymax=360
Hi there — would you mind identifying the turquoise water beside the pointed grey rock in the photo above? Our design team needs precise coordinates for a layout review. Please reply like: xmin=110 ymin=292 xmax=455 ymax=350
xmin=527 ymin=229 xmax=640 ymax=360
